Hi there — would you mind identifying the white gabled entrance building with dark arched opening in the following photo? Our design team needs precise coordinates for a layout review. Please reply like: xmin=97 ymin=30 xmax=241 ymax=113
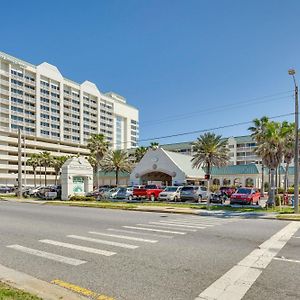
xmin=130 ymin=148 xmax=204 ymax=185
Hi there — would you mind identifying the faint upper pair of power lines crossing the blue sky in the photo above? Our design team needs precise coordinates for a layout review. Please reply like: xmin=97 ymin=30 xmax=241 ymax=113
xmin=141 ymin=91 xmax=292 ymax=127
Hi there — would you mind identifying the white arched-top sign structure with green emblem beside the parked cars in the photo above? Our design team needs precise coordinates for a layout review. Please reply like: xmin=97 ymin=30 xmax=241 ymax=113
xmin=60 ymin=157 xmax=93 ymax=200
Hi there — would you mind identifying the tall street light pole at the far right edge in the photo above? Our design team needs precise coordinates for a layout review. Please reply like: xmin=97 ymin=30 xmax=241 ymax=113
xmin=289 ymin=69 xmax=299 ymax=214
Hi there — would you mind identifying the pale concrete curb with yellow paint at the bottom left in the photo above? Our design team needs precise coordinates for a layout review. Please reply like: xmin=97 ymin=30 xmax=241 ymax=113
xmin=0 ymin=265 xmax=87 ymax=300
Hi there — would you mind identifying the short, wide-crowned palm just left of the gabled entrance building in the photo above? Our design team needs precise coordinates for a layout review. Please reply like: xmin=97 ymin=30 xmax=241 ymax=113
xmin=101 ymin=150 xmax=132 ymax=185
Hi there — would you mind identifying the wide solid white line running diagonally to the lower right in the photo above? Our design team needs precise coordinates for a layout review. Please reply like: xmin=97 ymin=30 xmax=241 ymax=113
xmin=196 ymin=222 xmax=300 ymax=300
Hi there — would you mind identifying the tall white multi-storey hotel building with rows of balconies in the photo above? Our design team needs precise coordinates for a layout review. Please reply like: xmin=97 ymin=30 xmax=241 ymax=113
xmin=0 ymin=52 xmax=139 ymax=186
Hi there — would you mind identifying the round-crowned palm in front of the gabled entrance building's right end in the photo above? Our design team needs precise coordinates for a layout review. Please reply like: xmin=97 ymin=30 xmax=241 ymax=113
xmin=191 ymin=132 xmax=229 ymax=205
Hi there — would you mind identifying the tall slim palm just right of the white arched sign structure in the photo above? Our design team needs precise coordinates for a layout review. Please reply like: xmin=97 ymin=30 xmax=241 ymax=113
xmin=87 ymin=134 xmax=109 ymax=187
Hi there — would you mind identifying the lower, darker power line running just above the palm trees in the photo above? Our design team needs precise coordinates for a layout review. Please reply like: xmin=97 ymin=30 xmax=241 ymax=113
xmin=118 ymin=113 xmax=295 ymax=144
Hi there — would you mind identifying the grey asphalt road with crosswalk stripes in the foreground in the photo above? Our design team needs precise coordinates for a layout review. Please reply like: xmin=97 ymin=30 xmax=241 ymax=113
xmin=0 ymin=202 xmax=300 ymax=300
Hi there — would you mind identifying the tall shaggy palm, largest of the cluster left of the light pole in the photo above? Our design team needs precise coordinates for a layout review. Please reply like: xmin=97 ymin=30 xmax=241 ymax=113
xmin=255 ymin=121 xmax=292 ymax=206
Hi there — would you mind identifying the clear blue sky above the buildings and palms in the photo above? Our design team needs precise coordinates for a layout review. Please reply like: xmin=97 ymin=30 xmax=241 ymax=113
xmin=0 ymin=0 xmax=300 ymax=145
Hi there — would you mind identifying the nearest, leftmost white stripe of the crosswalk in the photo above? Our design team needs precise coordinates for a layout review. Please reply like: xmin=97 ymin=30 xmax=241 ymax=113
xmin=6 ymin=245 xmax=86 ymax=266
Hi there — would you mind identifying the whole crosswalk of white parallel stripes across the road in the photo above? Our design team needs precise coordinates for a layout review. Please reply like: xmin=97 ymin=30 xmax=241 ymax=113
xmin=6 ymin=216 xmax=238 ymax=266
